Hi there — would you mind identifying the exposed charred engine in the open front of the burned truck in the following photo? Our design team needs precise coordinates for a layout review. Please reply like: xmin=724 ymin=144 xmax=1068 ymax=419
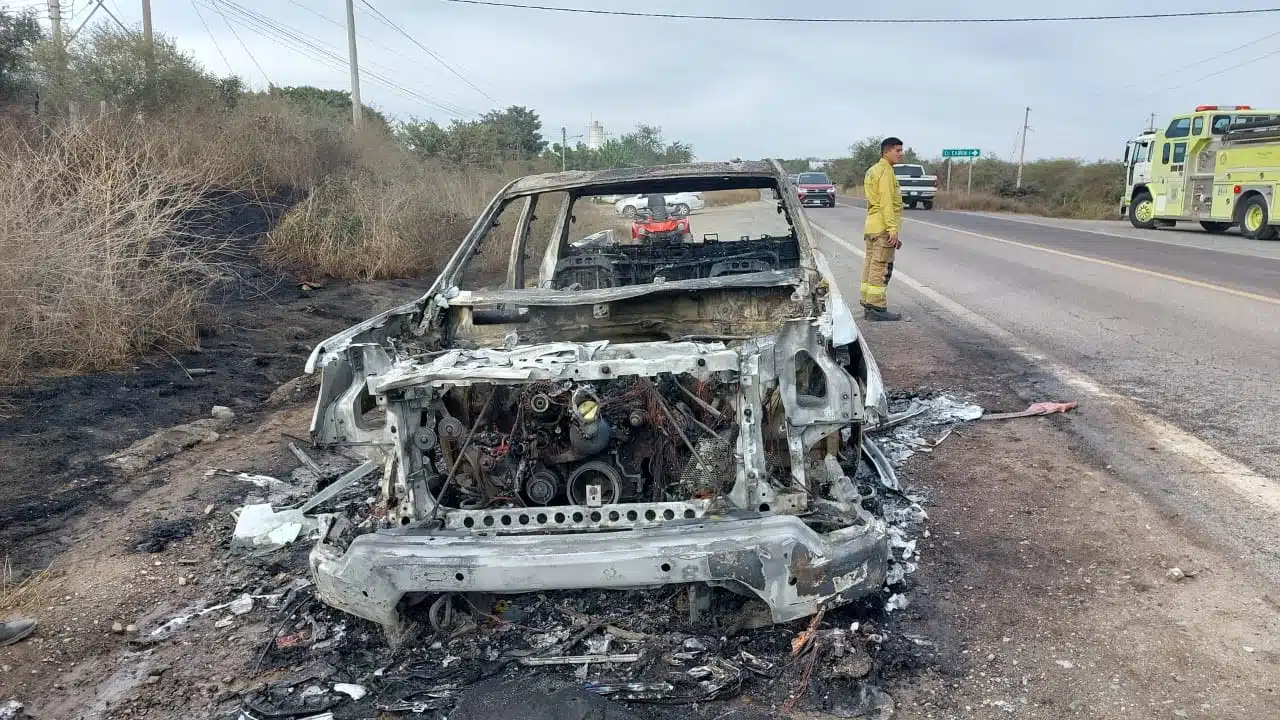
xmin=404 ymin=375 xmax=736 ymax=510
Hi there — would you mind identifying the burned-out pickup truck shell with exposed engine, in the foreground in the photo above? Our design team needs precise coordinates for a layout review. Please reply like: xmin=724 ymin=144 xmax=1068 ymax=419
xmin=307 ymin=161 xmax=888 ymax=626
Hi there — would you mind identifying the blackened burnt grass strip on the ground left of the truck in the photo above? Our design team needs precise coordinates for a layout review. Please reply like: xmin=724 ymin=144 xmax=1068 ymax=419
xmin=0 ymin=192 xmax=428 ymax=577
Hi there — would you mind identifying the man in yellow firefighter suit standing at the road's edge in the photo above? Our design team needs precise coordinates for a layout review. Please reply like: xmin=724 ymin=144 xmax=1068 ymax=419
xmin=863 ymin=137 xmax=902 ymax=322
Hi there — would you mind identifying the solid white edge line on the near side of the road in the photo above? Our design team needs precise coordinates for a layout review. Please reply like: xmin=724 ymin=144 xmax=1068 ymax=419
xmin=809 ymin=219 xmax=1280 ymax=512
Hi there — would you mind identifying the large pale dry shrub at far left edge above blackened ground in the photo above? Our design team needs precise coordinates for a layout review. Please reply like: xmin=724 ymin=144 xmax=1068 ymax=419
xmin=0 ymin=122 xmax=219 ymax=380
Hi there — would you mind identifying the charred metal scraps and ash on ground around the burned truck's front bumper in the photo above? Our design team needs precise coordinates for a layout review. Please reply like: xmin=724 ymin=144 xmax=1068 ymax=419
xmin=160 ymin=386 xmax=980 ymax=720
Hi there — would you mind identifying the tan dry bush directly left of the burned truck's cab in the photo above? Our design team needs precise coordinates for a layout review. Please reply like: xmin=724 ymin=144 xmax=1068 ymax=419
xmin=265 ymin=168 xmax=502 ymax=279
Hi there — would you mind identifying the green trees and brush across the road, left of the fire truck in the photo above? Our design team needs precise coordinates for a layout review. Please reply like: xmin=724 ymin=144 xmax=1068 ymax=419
xmin=783 ymin=137 xmax=1124 ymax=213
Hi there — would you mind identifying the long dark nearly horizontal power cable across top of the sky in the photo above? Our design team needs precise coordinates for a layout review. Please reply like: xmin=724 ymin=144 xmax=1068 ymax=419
xmin=435 ymin=0 xmax=1280 ymax=24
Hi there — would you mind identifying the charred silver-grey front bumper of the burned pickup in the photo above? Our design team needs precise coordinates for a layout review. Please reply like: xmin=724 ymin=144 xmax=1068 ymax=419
xmin=311 ymin=505 xmax=890 ymax=626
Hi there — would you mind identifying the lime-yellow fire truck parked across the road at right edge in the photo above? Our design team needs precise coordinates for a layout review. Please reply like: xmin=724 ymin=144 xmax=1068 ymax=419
xmin=1120 ymin=105 xmax=1280 ymax=240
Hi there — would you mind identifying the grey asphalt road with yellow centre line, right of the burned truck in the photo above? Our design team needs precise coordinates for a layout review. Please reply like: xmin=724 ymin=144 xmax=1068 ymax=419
xmin=808 ymin=200 xmax=1280 ymax=578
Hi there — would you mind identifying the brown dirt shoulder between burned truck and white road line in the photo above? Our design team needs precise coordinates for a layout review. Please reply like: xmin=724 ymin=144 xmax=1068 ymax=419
xmin=868 ymin=298 xmax=1280 ymax=719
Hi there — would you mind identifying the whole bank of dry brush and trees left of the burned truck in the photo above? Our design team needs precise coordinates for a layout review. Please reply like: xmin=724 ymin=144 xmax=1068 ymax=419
xmin=0 ymin=9 xmax=692 ymax=384
